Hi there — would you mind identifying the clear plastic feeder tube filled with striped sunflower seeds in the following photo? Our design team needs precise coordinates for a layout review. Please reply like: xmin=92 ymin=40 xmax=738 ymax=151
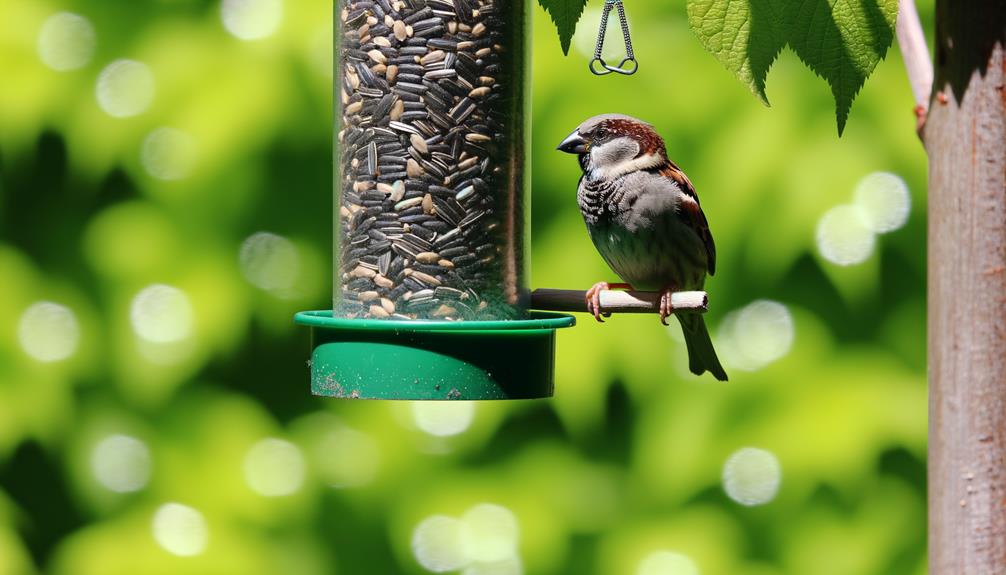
xmin=334 ymin=0 xmax=530 ymax=320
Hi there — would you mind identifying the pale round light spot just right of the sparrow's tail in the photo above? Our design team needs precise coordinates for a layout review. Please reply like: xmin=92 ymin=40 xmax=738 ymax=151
xmin=719 ymin=300 xmax=796 ymax=371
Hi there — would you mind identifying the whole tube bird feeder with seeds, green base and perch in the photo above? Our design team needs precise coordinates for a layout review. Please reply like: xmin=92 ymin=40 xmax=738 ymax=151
xmin=296 ymin=0 xmax=704 ymax=400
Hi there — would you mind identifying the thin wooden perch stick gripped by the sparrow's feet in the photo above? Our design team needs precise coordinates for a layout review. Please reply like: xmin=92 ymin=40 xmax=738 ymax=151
xmin=531 ymin=290 xmax=708 ymax=314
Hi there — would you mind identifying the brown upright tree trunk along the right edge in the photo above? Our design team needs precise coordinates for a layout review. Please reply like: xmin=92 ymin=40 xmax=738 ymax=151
xmin=925 ymin=0 xmax=1006 ymax=575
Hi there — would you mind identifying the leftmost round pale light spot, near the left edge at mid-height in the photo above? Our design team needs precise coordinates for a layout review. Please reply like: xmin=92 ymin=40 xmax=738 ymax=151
xmin=17 ymin=302 xmax=80 ymax=363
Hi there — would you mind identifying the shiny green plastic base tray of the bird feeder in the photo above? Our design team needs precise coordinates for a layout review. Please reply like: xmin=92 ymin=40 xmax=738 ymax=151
xmin=295 ymin=311 xmax=576 ymax=400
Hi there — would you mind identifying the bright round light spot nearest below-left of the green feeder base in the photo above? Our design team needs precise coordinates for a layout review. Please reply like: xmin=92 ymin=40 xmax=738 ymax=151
xmin=244 ymin=437 xmax=304 ymax=497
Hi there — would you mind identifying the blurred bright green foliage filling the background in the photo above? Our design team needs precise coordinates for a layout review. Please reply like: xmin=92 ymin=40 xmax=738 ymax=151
xmin=0 ymin=0 xmax=932 ymax=575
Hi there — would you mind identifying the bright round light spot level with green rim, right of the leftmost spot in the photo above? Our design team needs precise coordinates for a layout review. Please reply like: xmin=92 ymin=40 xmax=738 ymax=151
xmin=130 ymin=283 xmax=194 ymax=344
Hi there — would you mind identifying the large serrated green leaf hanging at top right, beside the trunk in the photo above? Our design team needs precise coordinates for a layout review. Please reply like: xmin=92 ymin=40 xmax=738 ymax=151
xmin=688 ymin=0 xmax=897 ymax=135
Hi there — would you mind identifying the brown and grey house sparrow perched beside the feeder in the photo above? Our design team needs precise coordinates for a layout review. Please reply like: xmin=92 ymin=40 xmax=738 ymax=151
xmin=558 ymin=114 xmax=726 ymax=381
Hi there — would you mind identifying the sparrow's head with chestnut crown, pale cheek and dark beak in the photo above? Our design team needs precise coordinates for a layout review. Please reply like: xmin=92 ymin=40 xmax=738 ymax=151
xmin=558 ymin=114 xmax=667 ymax=179
